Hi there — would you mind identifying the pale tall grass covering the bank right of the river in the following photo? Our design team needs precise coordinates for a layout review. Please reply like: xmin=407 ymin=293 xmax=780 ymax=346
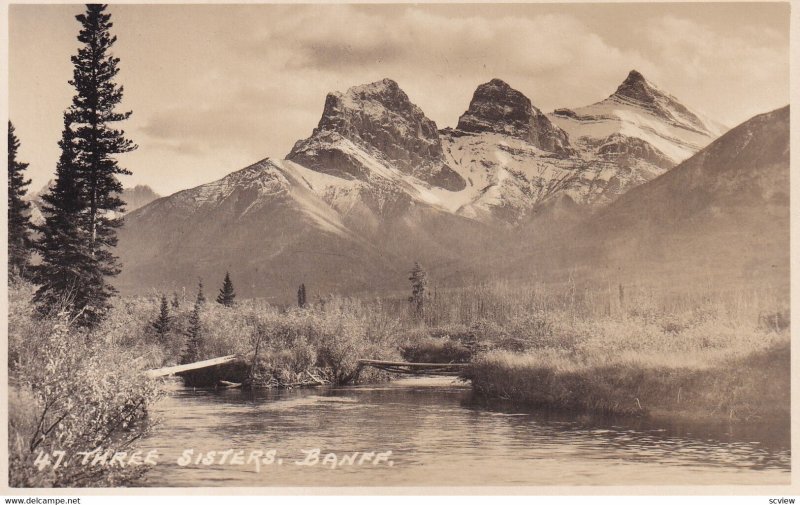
xmin=427 ymin=284 xmax=790 ymax=422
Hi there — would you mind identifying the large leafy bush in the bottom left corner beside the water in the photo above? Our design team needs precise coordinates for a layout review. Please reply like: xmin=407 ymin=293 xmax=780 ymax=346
xmin=9 ymin=284 xmax=159 ymax=487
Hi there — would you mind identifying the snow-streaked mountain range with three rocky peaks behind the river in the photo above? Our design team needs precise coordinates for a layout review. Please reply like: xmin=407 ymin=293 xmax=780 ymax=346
xmin=117 ymin=70 xmax=788 ymax=301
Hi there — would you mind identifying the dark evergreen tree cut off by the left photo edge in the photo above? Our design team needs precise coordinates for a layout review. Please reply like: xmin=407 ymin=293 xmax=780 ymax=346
xmin=8 ymin=121 xmax=31 ymax=276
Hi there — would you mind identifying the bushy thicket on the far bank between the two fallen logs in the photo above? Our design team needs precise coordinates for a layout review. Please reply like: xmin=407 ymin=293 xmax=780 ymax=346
xmin=170 ymin=297 xmax=398 ymax=386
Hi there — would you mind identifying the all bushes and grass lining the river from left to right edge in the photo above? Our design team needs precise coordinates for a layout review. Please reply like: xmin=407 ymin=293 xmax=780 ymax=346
xmin=9 ymin=276 xmax=790 ymax=485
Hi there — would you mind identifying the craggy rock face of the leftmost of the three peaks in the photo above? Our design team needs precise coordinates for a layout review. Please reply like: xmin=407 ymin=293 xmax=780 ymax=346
xmin=287 ymin=79 xmax=466 ymax=191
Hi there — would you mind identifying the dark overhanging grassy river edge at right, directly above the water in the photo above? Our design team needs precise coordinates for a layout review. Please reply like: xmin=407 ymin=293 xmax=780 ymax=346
xmin=467 ymin=326 xmax=791 ymax=422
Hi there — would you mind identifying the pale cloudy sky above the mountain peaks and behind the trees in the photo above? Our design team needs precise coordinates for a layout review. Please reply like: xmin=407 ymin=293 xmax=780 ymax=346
xmin=8 ymin=3 xmax=789 ymax=195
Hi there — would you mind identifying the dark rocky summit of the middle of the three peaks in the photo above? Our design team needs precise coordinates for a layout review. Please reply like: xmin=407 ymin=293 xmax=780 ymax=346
xmin=457 ymin=79 xmax=573 ymax=155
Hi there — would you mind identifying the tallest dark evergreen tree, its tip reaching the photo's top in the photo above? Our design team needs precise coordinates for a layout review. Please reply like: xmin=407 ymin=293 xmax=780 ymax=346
xmin=69 ymin=4 xmax=137 ymax=311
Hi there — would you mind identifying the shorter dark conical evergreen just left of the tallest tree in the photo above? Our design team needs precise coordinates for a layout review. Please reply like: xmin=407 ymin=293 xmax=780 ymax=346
xmin=33 ymin=114 xmax=98 ymax=318
